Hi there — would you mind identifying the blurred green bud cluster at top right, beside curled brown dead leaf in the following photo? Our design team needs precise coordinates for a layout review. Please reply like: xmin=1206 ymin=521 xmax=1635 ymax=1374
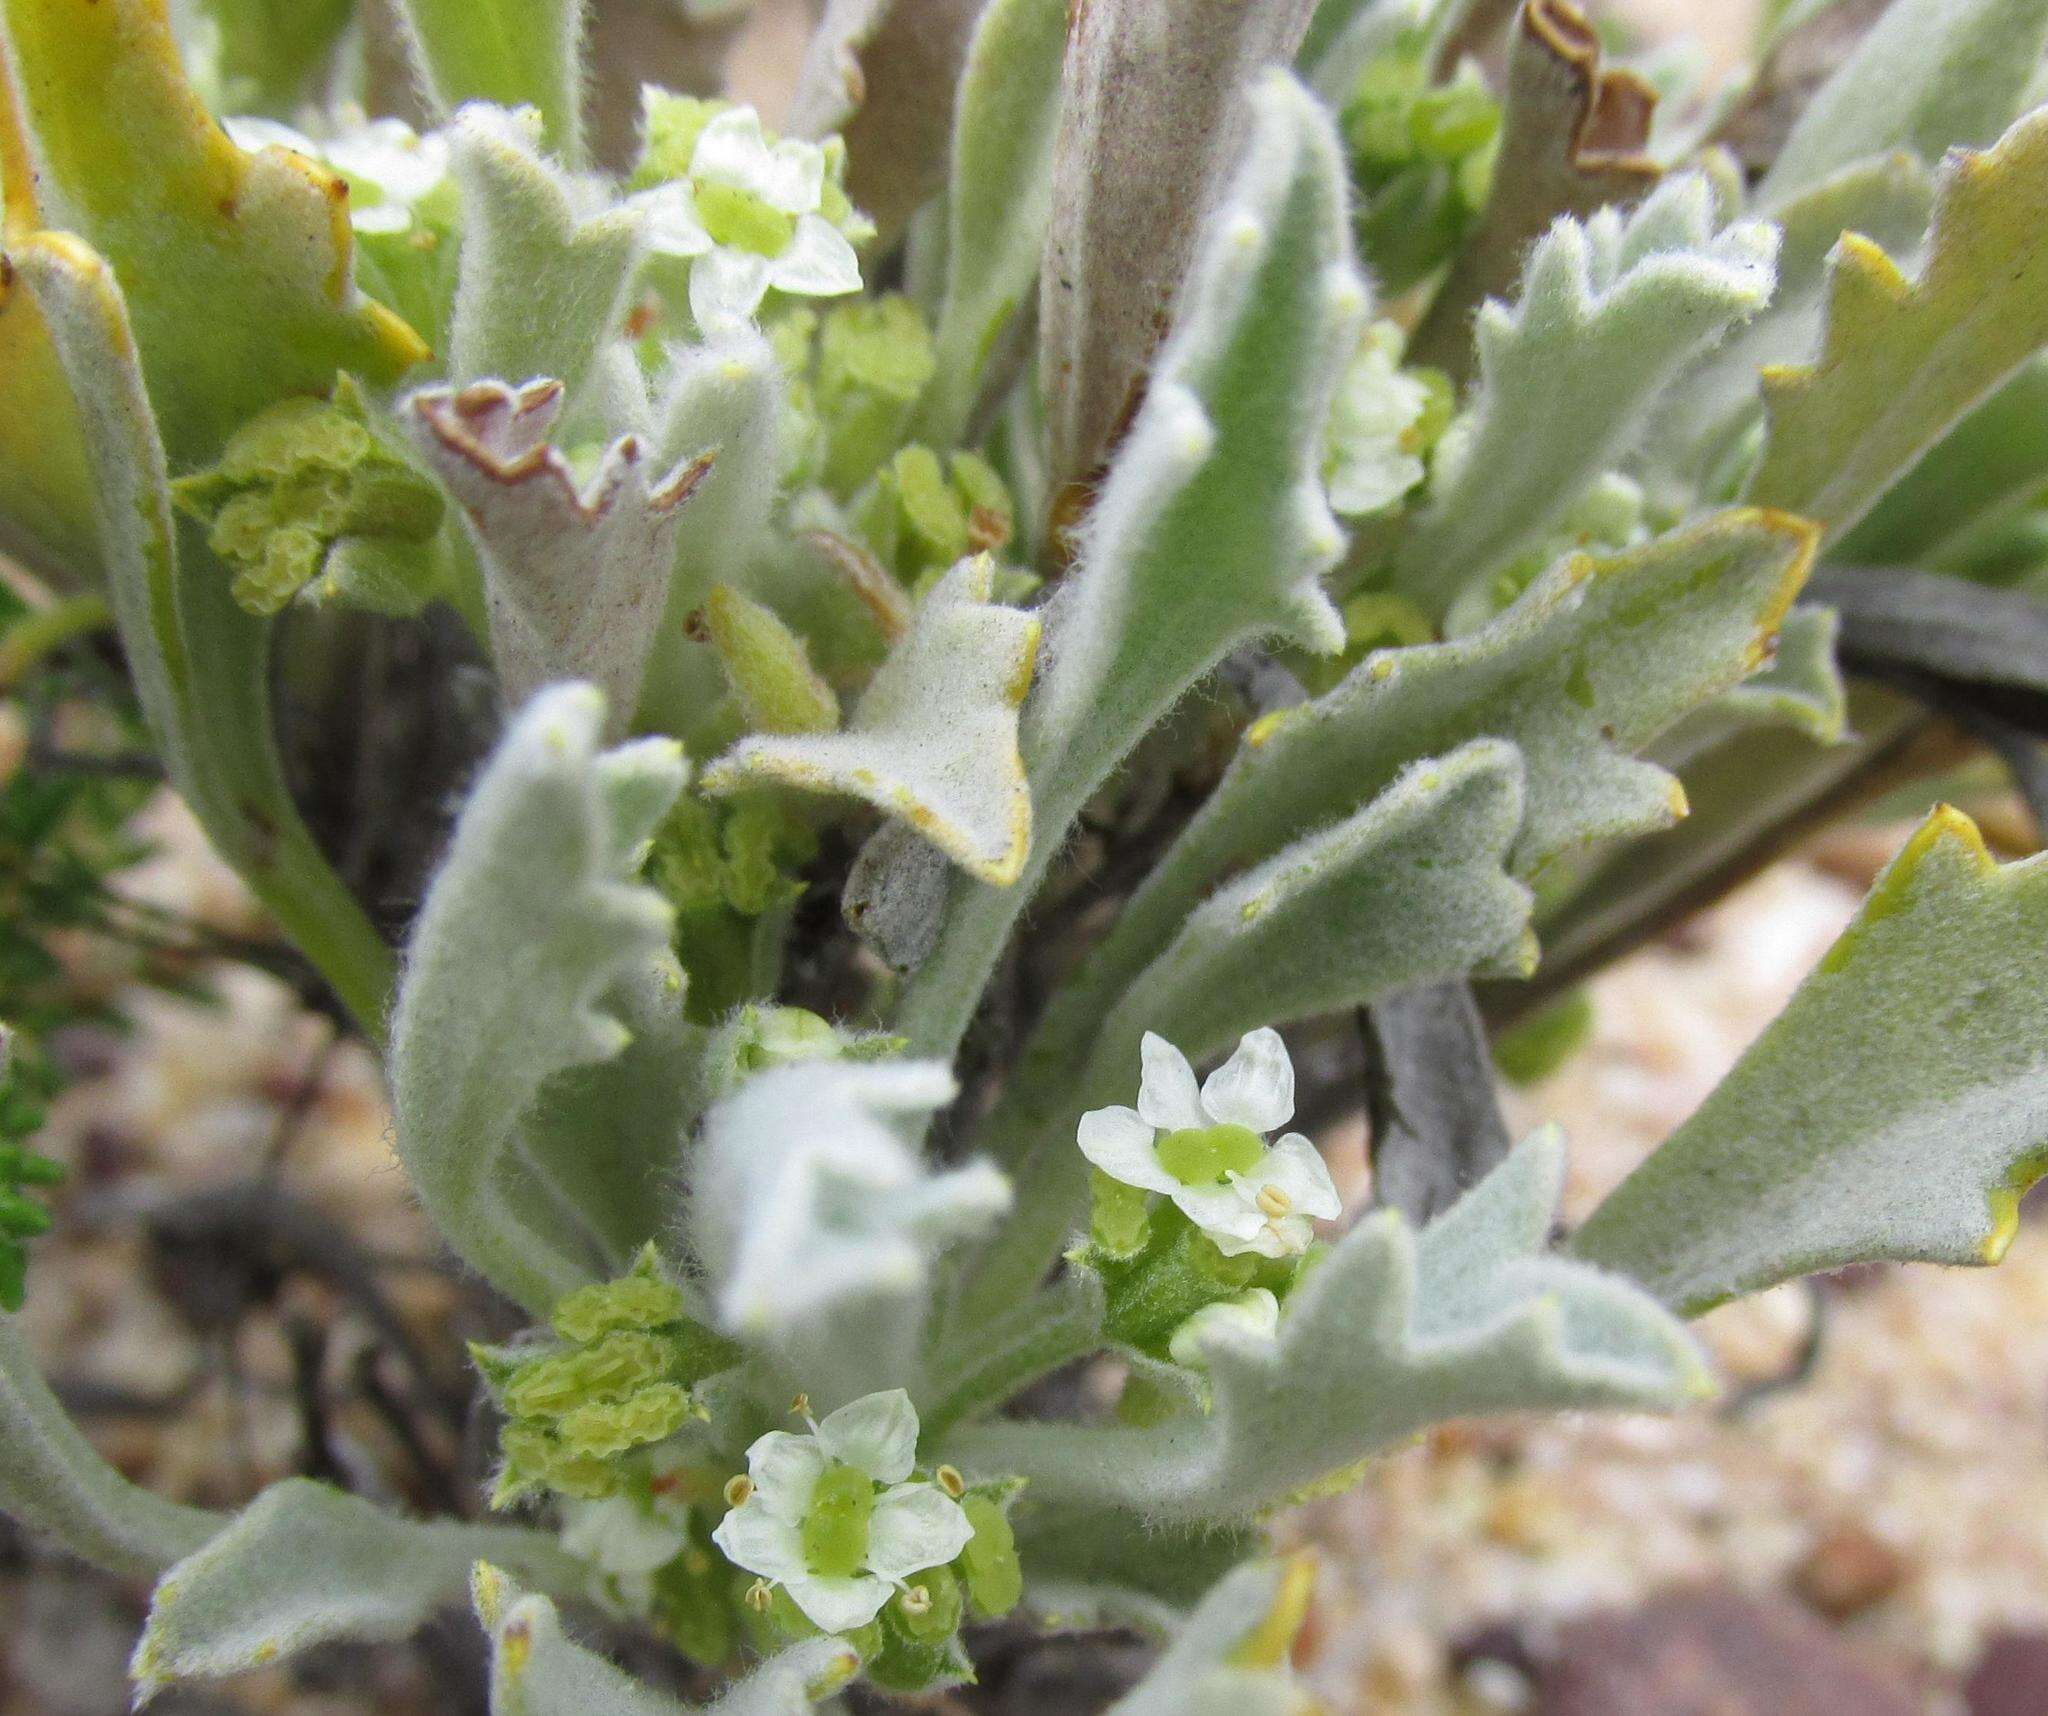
xmin=1341 ymin=31 xmax=1501 ymax=297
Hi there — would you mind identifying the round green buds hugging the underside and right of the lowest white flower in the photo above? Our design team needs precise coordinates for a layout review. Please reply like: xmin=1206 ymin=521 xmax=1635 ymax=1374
xmin=733 ymin=1466 xmax=1024 ymax=1693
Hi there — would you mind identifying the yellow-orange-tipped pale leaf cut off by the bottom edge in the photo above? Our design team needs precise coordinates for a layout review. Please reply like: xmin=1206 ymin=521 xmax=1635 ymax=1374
xmin=1104 ymin=1554 xmax=1321 ymax=1716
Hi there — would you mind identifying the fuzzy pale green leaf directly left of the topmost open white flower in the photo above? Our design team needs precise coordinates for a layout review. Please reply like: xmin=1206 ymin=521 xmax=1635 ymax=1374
xmin=449 ymin=105 xmax=641 ymax=426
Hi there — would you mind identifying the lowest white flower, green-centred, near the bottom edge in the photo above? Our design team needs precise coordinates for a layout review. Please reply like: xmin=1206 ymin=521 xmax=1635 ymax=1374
xmin=711 ymin=1388 xmax=975 ymax=1632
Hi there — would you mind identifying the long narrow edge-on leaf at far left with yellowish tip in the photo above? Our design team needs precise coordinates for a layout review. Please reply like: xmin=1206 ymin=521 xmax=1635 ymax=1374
xmin=8 ymin=233 xmax=391 ymax=1036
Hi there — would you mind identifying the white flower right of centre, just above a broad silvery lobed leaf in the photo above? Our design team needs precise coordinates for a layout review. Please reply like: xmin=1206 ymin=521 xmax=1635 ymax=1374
xmin=1079 ymin=1028 xmax=1343 ymax=1257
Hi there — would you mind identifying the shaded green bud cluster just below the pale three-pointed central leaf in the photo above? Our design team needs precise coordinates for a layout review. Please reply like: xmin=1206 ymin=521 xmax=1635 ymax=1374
xmin=647 ymin=792 xmax=817 ymax=1024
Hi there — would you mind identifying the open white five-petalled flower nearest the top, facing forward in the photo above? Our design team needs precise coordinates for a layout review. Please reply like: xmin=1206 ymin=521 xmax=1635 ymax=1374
xmin=627 ymin=106 xmax=860 ymax=334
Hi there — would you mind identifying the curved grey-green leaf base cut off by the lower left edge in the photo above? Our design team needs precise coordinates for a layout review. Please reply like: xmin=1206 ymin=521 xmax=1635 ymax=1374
xmin=0 ymin=1317 xmax=227 ymax=1575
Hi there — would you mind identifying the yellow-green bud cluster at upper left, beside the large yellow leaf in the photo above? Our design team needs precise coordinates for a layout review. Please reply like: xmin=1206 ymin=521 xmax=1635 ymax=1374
xmin=172 ymin=377 xmax=442 ymax=614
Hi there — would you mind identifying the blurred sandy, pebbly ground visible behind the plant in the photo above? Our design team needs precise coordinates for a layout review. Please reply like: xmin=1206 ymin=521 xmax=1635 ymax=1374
xmin=0 ymin=0 xmax=2048 ymax=1716
